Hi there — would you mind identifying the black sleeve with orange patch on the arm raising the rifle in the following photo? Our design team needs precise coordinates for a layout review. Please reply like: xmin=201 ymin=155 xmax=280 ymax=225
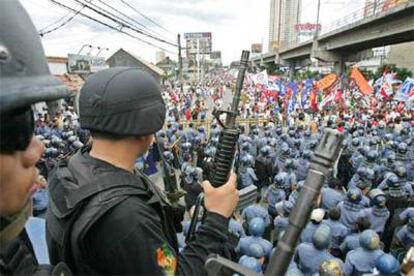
xmin=85 ymin=199 xmax=233 ymax=275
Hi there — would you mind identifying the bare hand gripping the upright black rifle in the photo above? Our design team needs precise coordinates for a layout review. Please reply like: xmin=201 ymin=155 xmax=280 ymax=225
xmin=203 ymin=172 xmax=239 ymax=218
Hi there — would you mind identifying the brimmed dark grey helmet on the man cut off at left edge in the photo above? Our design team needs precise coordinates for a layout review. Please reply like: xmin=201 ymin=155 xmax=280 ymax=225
xmin=0 ymin=1 xmax=68 ymax=113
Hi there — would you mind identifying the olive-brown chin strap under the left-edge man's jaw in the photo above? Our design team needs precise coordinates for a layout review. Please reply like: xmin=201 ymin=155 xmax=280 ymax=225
xmin=0 ymin=200 xmax=32 ymax=246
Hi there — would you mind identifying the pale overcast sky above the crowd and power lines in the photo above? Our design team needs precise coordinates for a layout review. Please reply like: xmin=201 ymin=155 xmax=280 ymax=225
xmin=21 ymin=0 xmax=364 ymax=64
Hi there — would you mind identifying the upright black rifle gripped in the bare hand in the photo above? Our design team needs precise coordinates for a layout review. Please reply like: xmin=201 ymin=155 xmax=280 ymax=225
xmin=186 ymin=51 xmax=257 ymax=241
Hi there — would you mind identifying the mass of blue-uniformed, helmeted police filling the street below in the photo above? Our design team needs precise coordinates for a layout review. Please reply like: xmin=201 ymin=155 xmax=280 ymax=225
xmin=158 ymin=111 xmax=414 ymax=275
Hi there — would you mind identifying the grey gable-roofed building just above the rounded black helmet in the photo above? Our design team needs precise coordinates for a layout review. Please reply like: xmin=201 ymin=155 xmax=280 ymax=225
xmin=106 ymin=48 xmax=164 ymax=83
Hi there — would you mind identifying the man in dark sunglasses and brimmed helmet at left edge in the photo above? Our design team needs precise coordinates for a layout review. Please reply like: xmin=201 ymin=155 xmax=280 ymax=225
xmin=0 ymin=0 xmax=70 ymax=275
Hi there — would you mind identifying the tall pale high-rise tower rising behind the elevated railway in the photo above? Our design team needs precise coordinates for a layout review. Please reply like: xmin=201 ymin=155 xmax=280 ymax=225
xmin=269 ymin=0 xmax=301 ymax=52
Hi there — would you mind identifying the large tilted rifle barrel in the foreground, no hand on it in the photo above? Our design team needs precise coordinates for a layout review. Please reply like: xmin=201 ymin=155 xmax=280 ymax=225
xmin=205 ymin=129 xmax=343 ymax=276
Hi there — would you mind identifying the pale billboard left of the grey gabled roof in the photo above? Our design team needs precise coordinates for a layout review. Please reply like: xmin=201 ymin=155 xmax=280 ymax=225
xmin=68 ymin=54 xmax=108 ymax=74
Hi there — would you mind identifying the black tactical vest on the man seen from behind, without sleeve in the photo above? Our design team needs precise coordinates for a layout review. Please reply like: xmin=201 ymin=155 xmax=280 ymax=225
xmin=46 ymin=148 xmax=178 ymax=274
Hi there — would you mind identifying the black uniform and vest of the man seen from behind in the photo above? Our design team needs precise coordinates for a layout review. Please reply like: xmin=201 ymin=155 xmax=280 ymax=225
xmin=46 ymin=147 xmax=233 ymax=275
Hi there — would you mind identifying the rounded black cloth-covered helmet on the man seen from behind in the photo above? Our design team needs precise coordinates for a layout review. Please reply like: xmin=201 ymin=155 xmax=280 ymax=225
xmin=79 ymin=67 xmax=165 ymax=136
